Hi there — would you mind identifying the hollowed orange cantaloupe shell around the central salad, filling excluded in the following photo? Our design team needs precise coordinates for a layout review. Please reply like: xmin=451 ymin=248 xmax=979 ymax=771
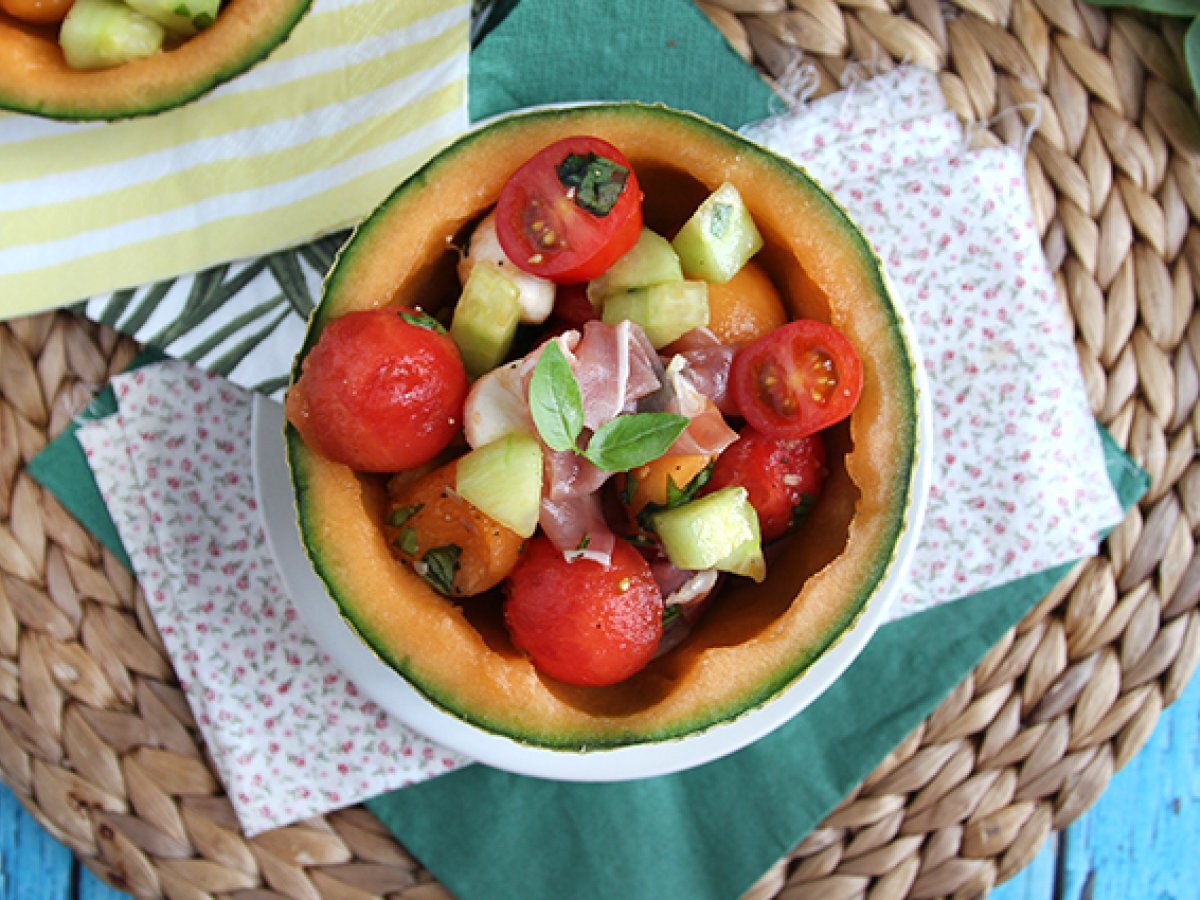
xmin=287 ymin=103 xmax=918 ymax=750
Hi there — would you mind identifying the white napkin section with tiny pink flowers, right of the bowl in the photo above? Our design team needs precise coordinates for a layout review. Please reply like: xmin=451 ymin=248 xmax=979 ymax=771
xmin=749 ymin=67 xmax=1122 ymax=618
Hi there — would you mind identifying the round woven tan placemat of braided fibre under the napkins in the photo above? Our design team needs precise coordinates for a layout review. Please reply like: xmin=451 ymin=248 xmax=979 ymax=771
xmin=0 ymin=0 xmax=1200 ymax=900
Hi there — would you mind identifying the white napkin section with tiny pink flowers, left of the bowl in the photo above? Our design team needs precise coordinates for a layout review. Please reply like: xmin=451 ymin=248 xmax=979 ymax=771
xmin=79 ymin=361 xmax=464 ymax=834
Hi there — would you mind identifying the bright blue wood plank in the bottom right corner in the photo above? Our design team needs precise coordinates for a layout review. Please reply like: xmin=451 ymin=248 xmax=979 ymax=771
xmin=1058 ymin=678 xmax=1200 ymax=900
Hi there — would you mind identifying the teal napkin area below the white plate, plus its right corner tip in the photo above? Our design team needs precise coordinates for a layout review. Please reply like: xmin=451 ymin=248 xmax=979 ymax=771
xmin=366 ymin=434 xmax=1148 ymax=900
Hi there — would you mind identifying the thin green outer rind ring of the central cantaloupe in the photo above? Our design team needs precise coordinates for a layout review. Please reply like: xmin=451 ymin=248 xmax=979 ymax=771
xmin=287 ymin=103 xmax=918 ymax=751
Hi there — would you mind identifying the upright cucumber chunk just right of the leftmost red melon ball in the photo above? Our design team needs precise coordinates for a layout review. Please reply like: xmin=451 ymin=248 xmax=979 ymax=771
xmin=450 ymin=263 xmax=521 ymax=378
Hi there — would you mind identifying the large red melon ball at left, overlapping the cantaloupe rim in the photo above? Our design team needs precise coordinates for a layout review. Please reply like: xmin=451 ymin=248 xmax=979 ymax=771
xmin=287 ymin=307 xmax=467 ymax=472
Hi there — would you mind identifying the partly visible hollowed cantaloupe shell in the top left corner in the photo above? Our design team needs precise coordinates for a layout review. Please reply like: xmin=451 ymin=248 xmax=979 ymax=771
xmin=0 ymin=0 xmax=312 ymax=121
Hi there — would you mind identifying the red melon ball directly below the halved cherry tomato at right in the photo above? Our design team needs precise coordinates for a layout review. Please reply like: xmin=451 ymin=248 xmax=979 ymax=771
xmin=704 ymin=427 xmax=826 ymax=542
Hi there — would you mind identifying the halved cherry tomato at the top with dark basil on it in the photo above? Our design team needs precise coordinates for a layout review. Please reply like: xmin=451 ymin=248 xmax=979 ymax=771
xmin=496 ymin=136 xmax=642 ymax=284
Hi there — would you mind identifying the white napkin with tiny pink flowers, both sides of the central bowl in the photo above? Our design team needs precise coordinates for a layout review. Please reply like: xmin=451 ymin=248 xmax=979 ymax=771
xmin=78 ymin=68 xmax=1121 ymax=833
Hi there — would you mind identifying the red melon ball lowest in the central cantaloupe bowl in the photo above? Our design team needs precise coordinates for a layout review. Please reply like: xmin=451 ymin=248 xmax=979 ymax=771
xmin=504 ymin=536 xmax=662 ymax=685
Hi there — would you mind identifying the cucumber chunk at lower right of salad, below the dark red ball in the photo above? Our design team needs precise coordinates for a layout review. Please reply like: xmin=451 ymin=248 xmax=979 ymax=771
xmin=650 ymin=485 xmax=767 ymax=581
